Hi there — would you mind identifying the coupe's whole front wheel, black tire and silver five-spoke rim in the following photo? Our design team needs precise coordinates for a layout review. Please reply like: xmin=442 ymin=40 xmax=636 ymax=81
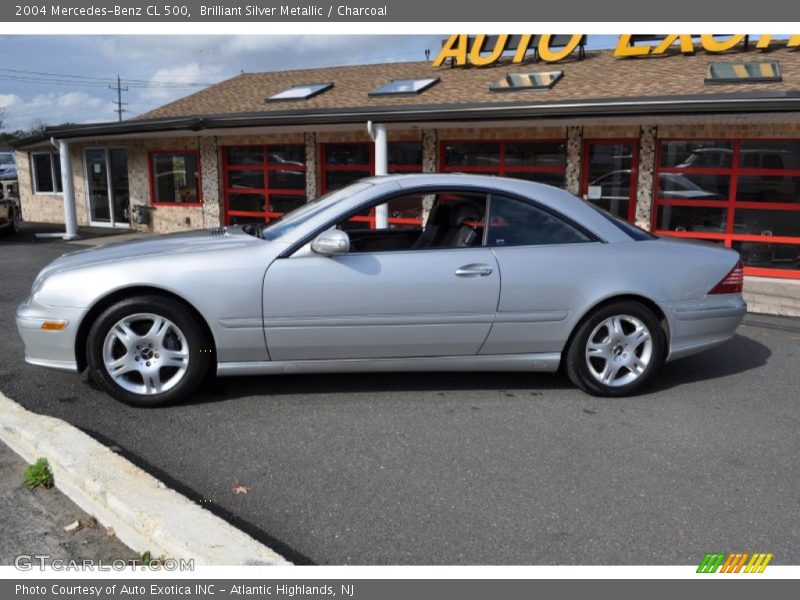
xmin=87 ymin=296 xmax=212 ymax=406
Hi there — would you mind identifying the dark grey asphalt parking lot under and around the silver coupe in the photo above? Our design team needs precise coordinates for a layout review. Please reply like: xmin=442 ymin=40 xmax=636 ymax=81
xmin=0 ymin=226 xmax=800 ymax=564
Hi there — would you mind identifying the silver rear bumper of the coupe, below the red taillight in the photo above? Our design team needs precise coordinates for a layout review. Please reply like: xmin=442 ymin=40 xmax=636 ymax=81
xmin=667 ymin=294 xmax=747 ymax=360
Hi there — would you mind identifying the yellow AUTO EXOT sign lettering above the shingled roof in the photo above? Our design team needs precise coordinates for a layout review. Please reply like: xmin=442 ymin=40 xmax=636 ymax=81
xmin=433 ymin=33 xmax=800 ymax=67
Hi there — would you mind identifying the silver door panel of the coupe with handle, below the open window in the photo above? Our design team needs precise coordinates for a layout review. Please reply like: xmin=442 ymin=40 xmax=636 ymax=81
xmin=263 ymin=192 xmax=500 ymax=361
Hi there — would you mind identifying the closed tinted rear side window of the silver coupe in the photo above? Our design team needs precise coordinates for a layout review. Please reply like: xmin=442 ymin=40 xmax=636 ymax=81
xmin=487 ymin=195 xmax=592 ymax=246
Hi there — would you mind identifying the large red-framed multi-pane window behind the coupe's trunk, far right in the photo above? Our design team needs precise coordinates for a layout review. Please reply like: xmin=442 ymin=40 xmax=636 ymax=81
xmin=654 ymin=139 xmax=800 ymax=277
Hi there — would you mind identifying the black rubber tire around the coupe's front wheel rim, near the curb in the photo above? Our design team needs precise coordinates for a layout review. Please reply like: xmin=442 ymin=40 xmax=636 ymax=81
xmin=86 ymin=295 xmax=214 ymax=407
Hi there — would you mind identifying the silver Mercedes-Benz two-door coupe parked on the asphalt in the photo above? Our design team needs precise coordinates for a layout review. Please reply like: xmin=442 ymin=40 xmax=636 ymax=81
xmin=17 ymin=175 xmax=746 ymax=406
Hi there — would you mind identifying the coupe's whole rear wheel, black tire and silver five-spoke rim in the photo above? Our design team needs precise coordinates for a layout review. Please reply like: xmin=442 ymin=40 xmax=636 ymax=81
xmin=566 ymin=301 xmax=666 ymax=397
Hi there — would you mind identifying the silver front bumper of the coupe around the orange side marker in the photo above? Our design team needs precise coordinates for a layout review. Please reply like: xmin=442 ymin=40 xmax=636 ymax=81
xmin=17 ymin=299 xmax=86 ymax=373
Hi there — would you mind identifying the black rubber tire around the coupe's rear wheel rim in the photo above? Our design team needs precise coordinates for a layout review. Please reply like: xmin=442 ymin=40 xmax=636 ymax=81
xmin=565 ymin=301 xmax=667 ymax=398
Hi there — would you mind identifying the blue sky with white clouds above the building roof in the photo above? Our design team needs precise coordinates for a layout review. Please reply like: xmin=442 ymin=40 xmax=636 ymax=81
xmin=0 ymin=34 xmax=616 ymax=131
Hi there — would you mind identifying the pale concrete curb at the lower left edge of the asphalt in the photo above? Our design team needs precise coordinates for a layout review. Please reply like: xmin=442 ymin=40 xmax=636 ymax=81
xmin=0 ymin=392 xmax=291 ymax=565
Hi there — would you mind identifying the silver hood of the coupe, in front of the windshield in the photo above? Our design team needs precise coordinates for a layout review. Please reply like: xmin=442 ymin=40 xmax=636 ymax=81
xmin=39 ymin=226 xmax=269 ymax=277
